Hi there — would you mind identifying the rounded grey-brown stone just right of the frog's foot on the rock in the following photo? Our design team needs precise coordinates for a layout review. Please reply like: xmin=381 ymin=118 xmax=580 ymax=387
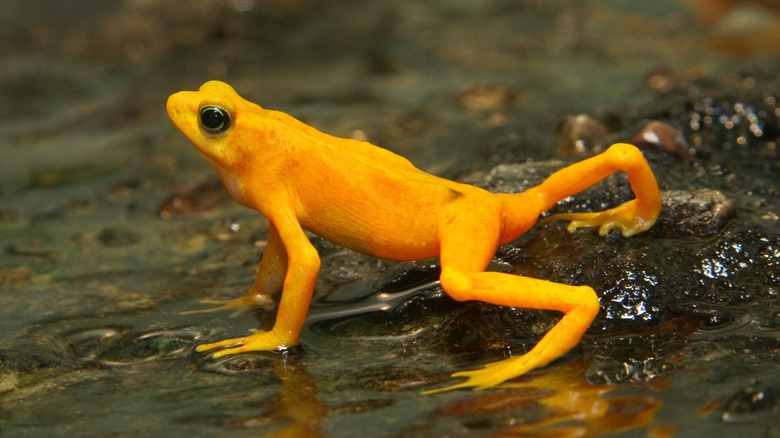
xmin=654 ymin=189 xmax=735 ymax=238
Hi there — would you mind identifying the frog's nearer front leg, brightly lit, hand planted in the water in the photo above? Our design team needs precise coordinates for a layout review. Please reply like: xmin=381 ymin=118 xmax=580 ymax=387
xmin=197 ymin=216 xmax=320 ymax=358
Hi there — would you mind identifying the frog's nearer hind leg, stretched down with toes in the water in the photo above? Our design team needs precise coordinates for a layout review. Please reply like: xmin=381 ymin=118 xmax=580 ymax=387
xmin=429 ymin=202 xmax=599 ymax=392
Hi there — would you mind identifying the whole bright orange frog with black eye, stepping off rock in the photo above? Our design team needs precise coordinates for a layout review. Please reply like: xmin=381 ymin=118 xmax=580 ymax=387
xmin=167 ymin=81 xmax=661 ymax=390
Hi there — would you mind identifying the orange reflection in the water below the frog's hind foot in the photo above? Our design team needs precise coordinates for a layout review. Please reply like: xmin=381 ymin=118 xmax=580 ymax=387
xmin=426 ymin=362 xmax=673 ymax=437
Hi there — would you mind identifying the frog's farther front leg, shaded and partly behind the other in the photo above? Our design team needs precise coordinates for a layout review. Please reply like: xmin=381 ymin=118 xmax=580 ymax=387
xmin=182 ymin=225 xmax=287 ymax=317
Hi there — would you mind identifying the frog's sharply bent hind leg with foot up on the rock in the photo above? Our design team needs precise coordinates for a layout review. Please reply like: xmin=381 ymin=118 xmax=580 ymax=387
xmin=531 ymin=143 xmax=661 ymax=237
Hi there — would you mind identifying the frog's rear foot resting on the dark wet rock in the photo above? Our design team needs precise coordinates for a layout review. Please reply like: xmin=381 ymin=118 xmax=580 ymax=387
xmin=544 ymin=199 xmax=658 ymax=237
